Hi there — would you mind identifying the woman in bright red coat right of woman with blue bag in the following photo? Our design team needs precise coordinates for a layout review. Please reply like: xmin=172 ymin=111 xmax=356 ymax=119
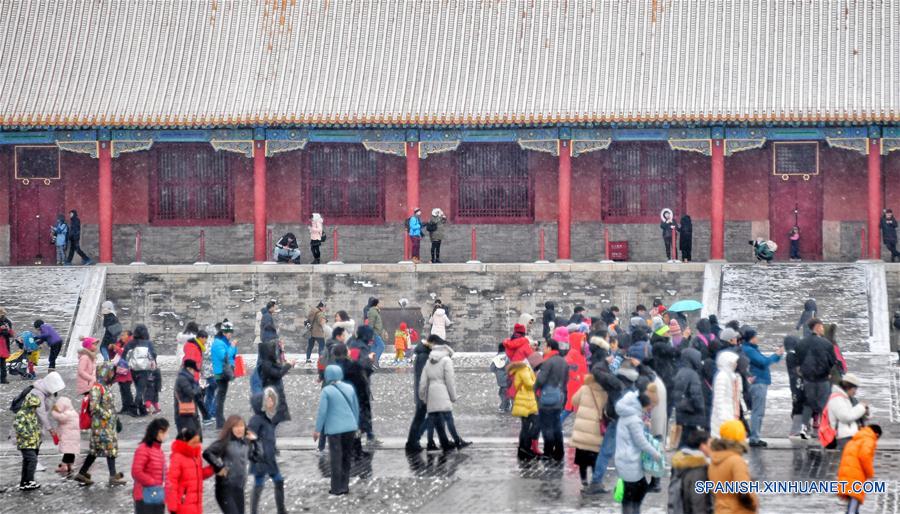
xmin=166 ymin=428 xmax=213 ymax=514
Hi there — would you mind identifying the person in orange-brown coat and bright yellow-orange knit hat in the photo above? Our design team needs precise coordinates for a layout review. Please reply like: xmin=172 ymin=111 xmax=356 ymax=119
xmin=707 ymin=419 xmax=759 ymax=514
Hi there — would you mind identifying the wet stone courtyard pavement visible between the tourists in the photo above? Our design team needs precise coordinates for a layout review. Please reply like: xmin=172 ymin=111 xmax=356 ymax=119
xmin=0 ymin=354 xmax=900 ymax=513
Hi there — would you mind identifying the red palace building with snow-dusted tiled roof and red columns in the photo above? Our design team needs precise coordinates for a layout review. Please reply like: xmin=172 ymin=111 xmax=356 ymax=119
xmin=0 ymin=0 xmax=900 ymax=265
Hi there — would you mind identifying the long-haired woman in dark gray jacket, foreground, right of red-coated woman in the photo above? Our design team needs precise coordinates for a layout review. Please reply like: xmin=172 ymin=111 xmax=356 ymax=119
xmin=203 ymin=414 xmax=261 ymax=514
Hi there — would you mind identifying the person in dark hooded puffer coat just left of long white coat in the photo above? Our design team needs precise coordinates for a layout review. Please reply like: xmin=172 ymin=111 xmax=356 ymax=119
xmin=670 ymin=348 xmax=709 ymax=448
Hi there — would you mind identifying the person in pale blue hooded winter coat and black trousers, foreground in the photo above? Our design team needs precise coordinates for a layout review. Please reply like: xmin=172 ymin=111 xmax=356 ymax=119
xmin=607 ymin=391 xmax=663 ymax=514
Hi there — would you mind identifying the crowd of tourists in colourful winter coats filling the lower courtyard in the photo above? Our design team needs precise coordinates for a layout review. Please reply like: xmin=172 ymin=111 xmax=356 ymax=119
xmin=0 ymin=292 xmax=881 ymax=513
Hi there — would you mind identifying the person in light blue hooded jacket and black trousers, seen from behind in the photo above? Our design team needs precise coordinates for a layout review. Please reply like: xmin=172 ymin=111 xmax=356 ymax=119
xmin=313 ymin=364 xmax=359 ymax=496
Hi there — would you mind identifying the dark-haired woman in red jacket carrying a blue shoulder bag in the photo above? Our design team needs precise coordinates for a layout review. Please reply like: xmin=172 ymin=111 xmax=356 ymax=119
xmin=131 ymin=418 xmax=169 ymax=514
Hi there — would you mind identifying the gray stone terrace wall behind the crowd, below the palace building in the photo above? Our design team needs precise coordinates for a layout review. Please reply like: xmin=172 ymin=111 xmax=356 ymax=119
xmin=106 ymin=264 xmax=703 ymax=353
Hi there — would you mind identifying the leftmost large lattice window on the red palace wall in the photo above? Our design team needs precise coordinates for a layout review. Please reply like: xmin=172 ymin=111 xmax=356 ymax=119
xmin=153 ymin=145 xmax=234 ymax=224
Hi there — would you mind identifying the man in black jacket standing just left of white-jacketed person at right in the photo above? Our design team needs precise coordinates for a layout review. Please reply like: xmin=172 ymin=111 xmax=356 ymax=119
xmin=797 ymin=318 xmax=837 ymax=432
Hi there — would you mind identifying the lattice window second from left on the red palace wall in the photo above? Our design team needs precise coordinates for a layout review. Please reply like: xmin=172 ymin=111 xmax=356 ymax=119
xmin=302 ymin=144 xmax=384 ymax=224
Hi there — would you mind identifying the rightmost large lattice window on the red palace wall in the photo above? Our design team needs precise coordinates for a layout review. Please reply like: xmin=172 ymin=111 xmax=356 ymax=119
xmin=602 ymin=143 xmax=682 ymax=223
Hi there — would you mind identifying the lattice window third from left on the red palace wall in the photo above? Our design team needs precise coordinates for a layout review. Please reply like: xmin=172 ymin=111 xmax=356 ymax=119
xmin=455 ymin=143 xmax=534 ymax=223
